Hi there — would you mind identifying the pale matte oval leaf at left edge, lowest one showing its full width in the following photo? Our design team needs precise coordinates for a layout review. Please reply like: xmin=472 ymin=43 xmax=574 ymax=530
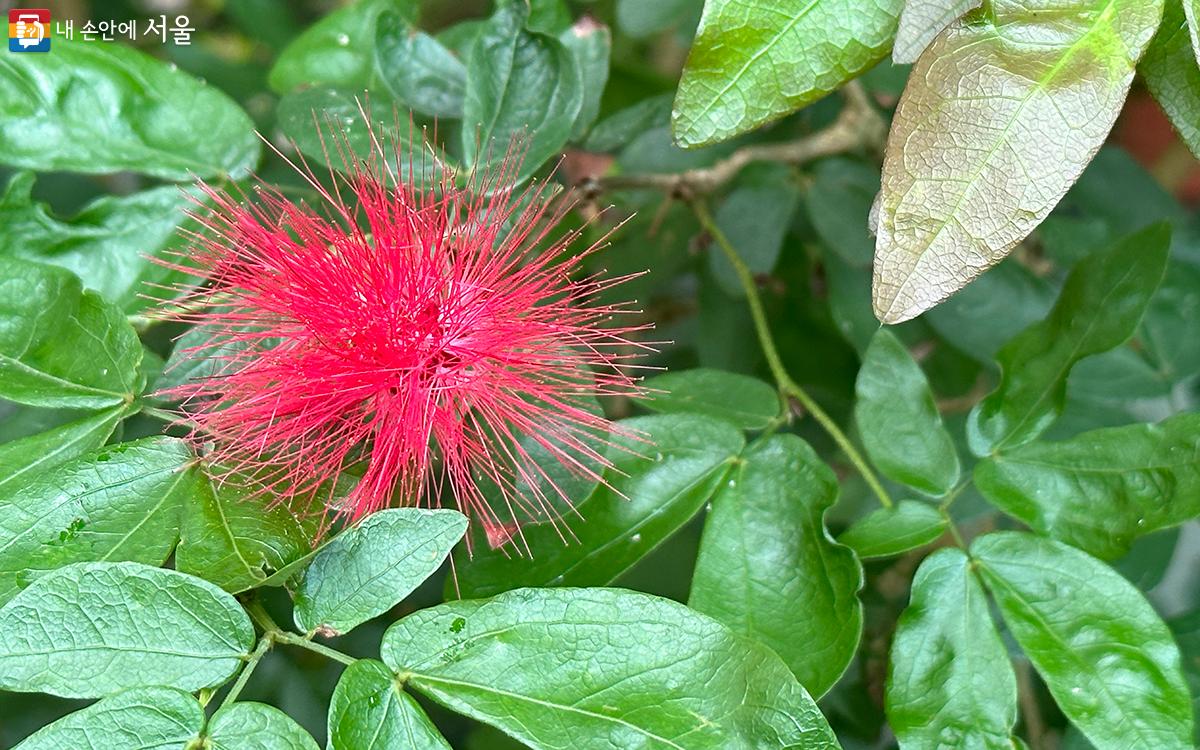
xmin=0 ymin=563 xmax=254 ymax=698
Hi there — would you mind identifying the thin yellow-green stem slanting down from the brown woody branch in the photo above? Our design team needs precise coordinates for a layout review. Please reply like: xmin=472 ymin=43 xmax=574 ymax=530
xmin=691 ymin=200 xmax=893 ymax=508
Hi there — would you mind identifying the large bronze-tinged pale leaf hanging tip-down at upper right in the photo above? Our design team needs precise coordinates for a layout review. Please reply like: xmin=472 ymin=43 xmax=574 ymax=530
xmin=874 ymin=0 xmax=1162 ymax=323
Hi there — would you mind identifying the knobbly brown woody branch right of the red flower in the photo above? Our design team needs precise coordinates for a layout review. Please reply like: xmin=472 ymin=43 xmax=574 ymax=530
xmin=577 ymin=82 xmax=887 ymax=200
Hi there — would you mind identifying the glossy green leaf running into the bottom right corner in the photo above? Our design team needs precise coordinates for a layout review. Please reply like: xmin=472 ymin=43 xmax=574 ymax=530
xmin=971 ymin=532 xmax=1193 ymax=750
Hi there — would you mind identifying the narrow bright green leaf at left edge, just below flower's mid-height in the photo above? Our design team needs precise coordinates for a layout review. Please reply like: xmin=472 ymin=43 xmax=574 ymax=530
xmin=0 ymin=407 xmax=125 ymax=494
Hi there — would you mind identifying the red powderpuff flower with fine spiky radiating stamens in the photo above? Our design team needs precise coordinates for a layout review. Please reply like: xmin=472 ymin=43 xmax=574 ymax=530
xmin=159 ymin=130 xmax=647 ymax=546
